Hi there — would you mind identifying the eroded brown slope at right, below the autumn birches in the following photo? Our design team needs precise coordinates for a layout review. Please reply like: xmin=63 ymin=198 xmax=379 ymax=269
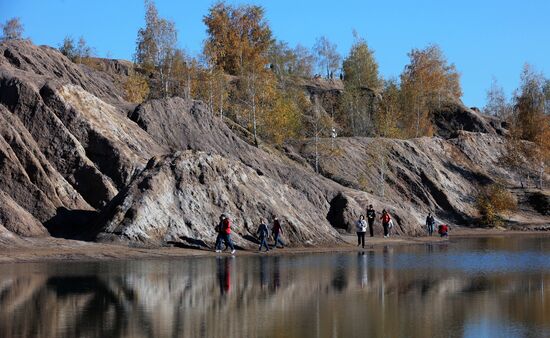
xmin=296 ymin=132 xmax=548 ymax=224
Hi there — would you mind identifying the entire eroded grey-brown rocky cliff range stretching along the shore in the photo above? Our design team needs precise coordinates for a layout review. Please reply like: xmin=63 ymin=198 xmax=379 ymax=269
xmin=0 ymin=41 xmax=548 ymax=247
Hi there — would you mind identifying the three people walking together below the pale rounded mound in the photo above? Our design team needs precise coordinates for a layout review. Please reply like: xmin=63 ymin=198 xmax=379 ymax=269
xmin=215 ymin=214 xmax=285 ymax=254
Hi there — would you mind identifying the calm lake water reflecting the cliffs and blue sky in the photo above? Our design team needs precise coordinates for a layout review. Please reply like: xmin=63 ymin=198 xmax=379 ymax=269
xmin=0 ymin=236 xmax=550 ymax=338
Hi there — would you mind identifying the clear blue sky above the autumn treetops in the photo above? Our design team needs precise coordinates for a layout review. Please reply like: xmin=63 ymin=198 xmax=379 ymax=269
xmin=0 ymin=0 xmax=550 ymax=107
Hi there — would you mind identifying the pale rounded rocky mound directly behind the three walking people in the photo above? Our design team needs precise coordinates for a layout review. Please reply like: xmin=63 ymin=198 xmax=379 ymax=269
xmin=98 ymin=151 xmax=338 ymax=246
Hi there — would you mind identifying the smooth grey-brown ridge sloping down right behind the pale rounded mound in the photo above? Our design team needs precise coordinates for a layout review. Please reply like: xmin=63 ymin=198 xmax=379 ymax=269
xmin=126 ymin=98 xmax=421 ymax=240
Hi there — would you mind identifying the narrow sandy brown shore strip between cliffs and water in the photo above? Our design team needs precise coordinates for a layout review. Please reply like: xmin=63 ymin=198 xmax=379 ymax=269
xmin=0 ymin=228 xmax=550 ymax=265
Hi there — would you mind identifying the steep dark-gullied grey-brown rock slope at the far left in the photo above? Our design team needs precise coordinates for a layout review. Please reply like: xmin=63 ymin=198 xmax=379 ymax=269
xmin=0 ymin=41 xmax=165 ymax=239
